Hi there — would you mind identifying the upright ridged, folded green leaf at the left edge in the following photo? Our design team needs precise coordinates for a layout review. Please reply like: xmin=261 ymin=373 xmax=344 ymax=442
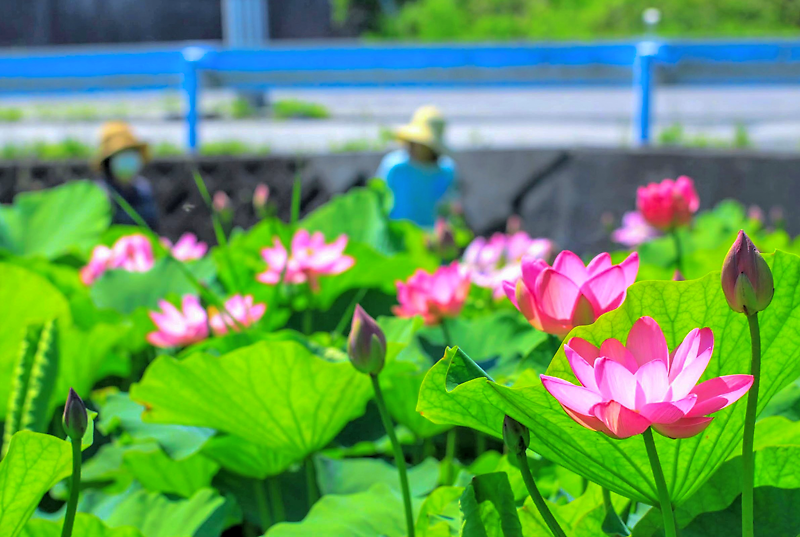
xmin=3 ymin=320 xmax=59 ymax=455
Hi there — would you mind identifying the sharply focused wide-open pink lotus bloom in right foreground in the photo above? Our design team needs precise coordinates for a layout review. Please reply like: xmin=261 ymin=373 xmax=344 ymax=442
xmin=542 ymin=317 xmax=753 ymax=438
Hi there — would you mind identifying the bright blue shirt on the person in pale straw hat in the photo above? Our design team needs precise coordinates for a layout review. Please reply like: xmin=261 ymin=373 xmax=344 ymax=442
xmin=377 ymin=149 xmax=456 ymax=227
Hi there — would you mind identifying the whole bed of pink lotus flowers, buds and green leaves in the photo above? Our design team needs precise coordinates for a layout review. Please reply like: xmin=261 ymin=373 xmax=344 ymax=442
xmin=0 ymin=178 xmax=800 ymax=537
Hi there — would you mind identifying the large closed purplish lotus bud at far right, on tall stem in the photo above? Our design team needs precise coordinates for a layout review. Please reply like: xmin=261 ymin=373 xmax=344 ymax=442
xmin=722 ymin=231 xmax=775 ymax=315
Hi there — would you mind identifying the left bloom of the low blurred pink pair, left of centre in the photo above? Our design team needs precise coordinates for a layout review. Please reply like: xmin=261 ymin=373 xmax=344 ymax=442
xmin=147 ymin=295 xmax=208 ymax=348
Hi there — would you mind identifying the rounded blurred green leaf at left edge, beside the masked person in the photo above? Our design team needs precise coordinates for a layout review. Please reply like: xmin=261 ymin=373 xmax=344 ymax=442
xmin=0 ymin=181 xmax=111 ymax=259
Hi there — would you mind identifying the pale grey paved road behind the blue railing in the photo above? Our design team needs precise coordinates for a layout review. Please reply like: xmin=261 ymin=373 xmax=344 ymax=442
xmin=0 ymin=85 xmax=800 ymax=152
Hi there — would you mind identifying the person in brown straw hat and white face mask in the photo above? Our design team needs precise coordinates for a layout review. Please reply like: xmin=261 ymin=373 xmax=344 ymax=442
xmin=92 ymin=121 xmax=158 ymax=229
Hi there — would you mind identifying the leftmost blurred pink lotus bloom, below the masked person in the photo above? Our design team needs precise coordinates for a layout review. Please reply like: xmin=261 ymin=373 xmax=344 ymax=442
xmin=80 ymin=234 xmax=155 ymax=285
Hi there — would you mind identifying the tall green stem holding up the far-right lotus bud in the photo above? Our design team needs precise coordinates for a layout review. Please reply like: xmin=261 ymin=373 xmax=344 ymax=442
xmin=742 ymin=313 xmax=761 ymax=537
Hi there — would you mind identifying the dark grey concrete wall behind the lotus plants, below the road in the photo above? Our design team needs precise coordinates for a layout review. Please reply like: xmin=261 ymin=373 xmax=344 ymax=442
xmin=0 ymin=149 xmax=800 ymax=252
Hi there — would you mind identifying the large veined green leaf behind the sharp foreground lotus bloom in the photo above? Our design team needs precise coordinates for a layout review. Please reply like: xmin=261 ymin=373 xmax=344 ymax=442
xmin=418 ymin=252 xmax=800 ymax=505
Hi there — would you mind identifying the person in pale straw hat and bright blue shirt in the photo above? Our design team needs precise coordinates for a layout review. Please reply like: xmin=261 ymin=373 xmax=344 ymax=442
xmin=377 ymin=106 xmax=456 ymax=228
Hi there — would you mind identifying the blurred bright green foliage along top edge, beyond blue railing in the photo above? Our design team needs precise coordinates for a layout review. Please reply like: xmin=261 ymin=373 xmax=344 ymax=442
xmin=372 ymin=0 xmax=800 ymax=41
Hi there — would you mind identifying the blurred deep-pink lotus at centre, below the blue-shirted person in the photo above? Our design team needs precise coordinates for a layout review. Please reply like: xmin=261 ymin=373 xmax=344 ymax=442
xmin=392 ymin=261 xmax=470 ymax=325
